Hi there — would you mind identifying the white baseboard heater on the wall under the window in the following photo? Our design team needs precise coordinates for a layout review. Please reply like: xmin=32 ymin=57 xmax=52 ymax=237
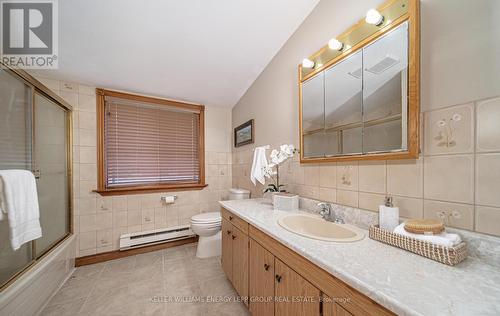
xmin=120 ymin=225 xmax=195 ymax=250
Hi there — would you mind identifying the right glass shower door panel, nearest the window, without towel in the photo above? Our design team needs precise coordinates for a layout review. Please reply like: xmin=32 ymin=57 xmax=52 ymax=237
xmin=34 ymin=92 xmax=70 ymax=258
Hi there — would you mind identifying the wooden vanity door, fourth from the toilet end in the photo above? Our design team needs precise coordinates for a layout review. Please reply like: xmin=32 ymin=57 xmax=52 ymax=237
xmin=274 ymin=259 xmax=320 ymax=316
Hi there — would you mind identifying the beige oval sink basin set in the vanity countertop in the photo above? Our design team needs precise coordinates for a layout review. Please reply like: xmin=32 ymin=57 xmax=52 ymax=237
xmin=278 ymin=214 xmax=365 ymax=242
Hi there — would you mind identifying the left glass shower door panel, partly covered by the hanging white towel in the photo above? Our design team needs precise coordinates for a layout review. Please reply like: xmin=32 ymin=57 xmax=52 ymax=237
xmin=0 ymin=69 xmax=33 ymax=286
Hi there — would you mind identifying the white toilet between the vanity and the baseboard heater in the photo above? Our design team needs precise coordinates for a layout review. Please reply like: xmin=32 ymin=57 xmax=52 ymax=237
xmin=191 ymin=188 xmax=250 ymax=258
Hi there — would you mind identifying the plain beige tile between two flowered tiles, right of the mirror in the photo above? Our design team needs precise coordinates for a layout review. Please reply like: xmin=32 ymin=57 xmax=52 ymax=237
xmin=424 ymin=155 xmax=474 ymax=204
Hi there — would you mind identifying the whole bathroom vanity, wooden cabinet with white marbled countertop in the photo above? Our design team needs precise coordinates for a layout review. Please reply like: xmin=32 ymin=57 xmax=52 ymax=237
xmin=220 ymin=199 xmax=500 ymax=316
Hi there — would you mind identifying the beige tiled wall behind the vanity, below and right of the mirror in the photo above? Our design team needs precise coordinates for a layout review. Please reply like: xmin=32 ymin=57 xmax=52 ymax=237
xmin=232 ymin=97 xmax=500 ymax=236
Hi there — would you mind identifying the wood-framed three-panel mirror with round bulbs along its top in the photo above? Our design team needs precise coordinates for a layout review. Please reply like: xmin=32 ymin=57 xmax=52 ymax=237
xmin=299 ymin=0 xmax=420 ymax=163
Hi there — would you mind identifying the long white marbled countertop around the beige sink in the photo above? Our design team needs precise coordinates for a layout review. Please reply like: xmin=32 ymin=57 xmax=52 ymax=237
xmin=220 ymin=199 xmax=500 ymax=316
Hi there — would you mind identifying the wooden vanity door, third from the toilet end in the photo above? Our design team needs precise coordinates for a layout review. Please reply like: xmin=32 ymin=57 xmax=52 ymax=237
xmin=249 ymin=239 xmax=274 ymax=316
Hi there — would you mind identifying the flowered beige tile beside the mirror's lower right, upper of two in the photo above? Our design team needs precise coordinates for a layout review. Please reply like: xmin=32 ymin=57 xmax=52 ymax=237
xmin=424 ymin=104 xmax=474 ymax=155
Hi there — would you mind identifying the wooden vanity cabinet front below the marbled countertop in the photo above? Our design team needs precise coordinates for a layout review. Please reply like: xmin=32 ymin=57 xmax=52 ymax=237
xmin=221 ymin=207 xmax=393 ymax=316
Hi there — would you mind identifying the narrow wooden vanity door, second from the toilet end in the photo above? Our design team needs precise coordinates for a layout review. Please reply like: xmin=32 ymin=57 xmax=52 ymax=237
xmin=231 ymin=226 xmax=248 ymax=305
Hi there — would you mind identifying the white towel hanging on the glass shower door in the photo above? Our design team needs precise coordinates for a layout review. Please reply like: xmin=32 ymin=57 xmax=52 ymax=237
xmin=0 ymin=170 xmax=42 ymax=250
